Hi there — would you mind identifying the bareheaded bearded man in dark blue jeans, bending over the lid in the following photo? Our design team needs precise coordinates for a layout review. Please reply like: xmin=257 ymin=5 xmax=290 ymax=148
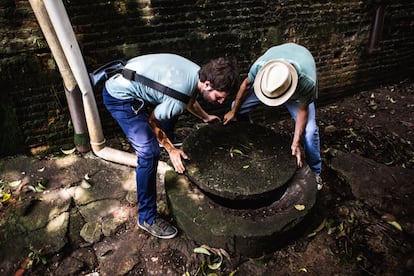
xmin=103 ymin=54 xmax=239 ymax=239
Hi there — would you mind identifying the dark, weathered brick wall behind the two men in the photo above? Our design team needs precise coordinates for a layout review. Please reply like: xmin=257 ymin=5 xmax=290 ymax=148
xmin=0 ymin=0 xmax=414 ymax=155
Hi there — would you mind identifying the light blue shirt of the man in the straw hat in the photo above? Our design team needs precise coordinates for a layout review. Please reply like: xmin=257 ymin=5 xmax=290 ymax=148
xmin=247 ymin=43 xmax=317 ymax=105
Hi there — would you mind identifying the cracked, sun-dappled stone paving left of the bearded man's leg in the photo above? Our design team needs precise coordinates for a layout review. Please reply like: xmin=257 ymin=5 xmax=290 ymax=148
xmin=0 ymin=153 xmax=168 ymax=275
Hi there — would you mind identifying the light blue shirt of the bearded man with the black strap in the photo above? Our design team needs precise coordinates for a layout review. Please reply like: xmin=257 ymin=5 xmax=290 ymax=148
xmin=105 ymin=54 xmax=200 ymax=121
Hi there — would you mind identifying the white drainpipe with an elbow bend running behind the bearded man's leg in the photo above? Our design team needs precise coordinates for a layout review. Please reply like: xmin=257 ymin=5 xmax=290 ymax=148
xmin=30 ymin=0 xmax=137 ymax=167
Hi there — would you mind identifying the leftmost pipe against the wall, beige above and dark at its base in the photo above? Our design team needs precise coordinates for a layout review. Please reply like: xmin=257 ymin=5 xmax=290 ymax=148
xmin=30 ymin=0 xmax=90 ymax=152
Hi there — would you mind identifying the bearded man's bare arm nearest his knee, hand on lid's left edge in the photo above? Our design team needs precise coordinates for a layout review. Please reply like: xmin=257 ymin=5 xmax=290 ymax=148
xmin=148 ymin=112 xmax=188 ymax=173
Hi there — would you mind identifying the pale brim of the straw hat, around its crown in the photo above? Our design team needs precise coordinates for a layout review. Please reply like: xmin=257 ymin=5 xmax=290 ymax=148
xmin=253 ymin=59 xmax=298 ymax=106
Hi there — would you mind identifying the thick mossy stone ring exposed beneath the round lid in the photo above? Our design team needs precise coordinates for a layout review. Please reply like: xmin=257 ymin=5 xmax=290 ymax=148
xmin=165 ymin=166 xmax=317 ymax=256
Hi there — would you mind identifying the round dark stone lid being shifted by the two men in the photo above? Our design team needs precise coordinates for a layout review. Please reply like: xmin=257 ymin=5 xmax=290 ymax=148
xmin=183 ymin=122 xmax=297 ymax=200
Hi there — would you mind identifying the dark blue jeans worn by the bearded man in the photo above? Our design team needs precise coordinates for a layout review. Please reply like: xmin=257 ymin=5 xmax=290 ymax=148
xmin=102 ymin=88 xmax=160 ymax=224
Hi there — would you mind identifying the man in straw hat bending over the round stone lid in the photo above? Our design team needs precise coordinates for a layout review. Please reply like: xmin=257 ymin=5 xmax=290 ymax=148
xmin=223 ymin=43 xmax=322 ymax=189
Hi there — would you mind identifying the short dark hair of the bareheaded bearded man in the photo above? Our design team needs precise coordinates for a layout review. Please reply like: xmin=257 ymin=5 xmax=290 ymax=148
xmin=198 ymin=57 xmax=240 ymax=94
